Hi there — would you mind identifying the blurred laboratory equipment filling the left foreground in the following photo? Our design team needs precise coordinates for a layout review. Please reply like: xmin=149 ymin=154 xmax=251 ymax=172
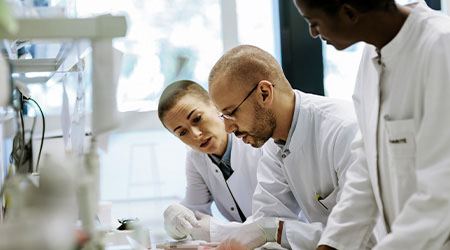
xmin=0 ymin=3 xmax=127 ymax=250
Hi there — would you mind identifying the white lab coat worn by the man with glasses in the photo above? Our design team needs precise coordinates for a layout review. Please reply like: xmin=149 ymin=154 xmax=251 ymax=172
xmin=253 ymin=90 xmax=358 ymax=249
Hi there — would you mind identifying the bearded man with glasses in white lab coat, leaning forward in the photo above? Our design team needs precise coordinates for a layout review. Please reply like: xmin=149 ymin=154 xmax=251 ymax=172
xmin=209 ymin=45 xmax=359 ymax=249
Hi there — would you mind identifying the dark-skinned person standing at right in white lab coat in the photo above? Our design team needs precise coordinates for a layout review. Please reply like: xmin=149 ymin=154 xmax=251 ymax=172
xmin=296 ymin=0 xmax=450 ymax=250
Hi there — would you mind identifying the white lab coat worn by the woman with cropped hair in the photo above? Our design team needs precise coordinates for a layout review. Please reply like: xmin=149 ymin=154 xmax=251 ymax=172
xmin=181 ymin=135 xmax=262 ymax=228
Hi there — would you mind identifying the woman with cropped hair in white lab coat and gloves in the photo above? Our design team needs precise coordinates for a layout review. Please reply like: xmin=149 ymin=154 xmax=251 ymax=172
xmin=158 ymin=80 xmax=262 ymax=241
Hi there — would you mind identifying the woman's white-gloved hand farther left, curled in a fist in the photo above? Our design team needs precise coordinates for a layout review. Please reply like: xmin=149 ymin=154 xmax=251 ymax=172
xmin=164 ymin=204 xmax=199 ymax=240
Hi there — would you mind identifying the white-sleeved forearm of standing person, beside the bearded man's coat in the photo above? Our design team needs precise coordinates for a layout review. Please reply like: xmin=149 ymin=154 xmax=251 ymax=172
xmin=319 ymin=140 xmax=378 ymax=249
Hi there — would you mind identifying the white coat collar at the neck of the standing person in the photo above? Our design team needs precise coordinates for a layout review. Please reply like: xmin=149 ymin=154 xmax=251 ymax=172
xmin=379 ymin=0 xmax=429 ymax=62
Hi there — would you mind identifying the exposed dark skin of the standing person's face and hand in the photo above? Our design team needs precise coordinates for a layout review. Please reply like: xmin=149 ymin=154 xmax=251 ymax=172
xmin=296 ymin=0 xmax=413 ymax=250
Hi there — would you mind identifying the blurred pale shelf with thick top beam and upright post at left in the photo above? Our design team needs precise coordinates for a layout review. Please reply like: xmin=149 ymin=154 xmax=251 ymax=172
xmin=0 ymin=15 xmax=127 ymax=135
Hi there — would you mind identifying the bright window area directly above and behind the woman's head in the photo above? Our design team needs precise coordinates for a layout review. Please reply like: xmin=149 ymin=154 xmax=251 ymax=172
xmin=77 ymin=0 xmax=223 ymax=111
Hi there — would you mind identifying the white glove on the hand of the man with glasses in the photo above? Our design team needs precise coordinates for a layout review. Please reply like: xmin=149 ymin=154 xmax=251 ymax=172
xmin=217 ymin=217 xmax=279 ymax=250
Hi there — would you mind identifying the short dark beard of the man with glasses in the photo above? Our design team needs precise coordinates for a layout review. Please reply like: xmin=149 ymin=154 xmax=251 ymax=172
xmin=247 ymin=102 xmax=277 ymax=148
